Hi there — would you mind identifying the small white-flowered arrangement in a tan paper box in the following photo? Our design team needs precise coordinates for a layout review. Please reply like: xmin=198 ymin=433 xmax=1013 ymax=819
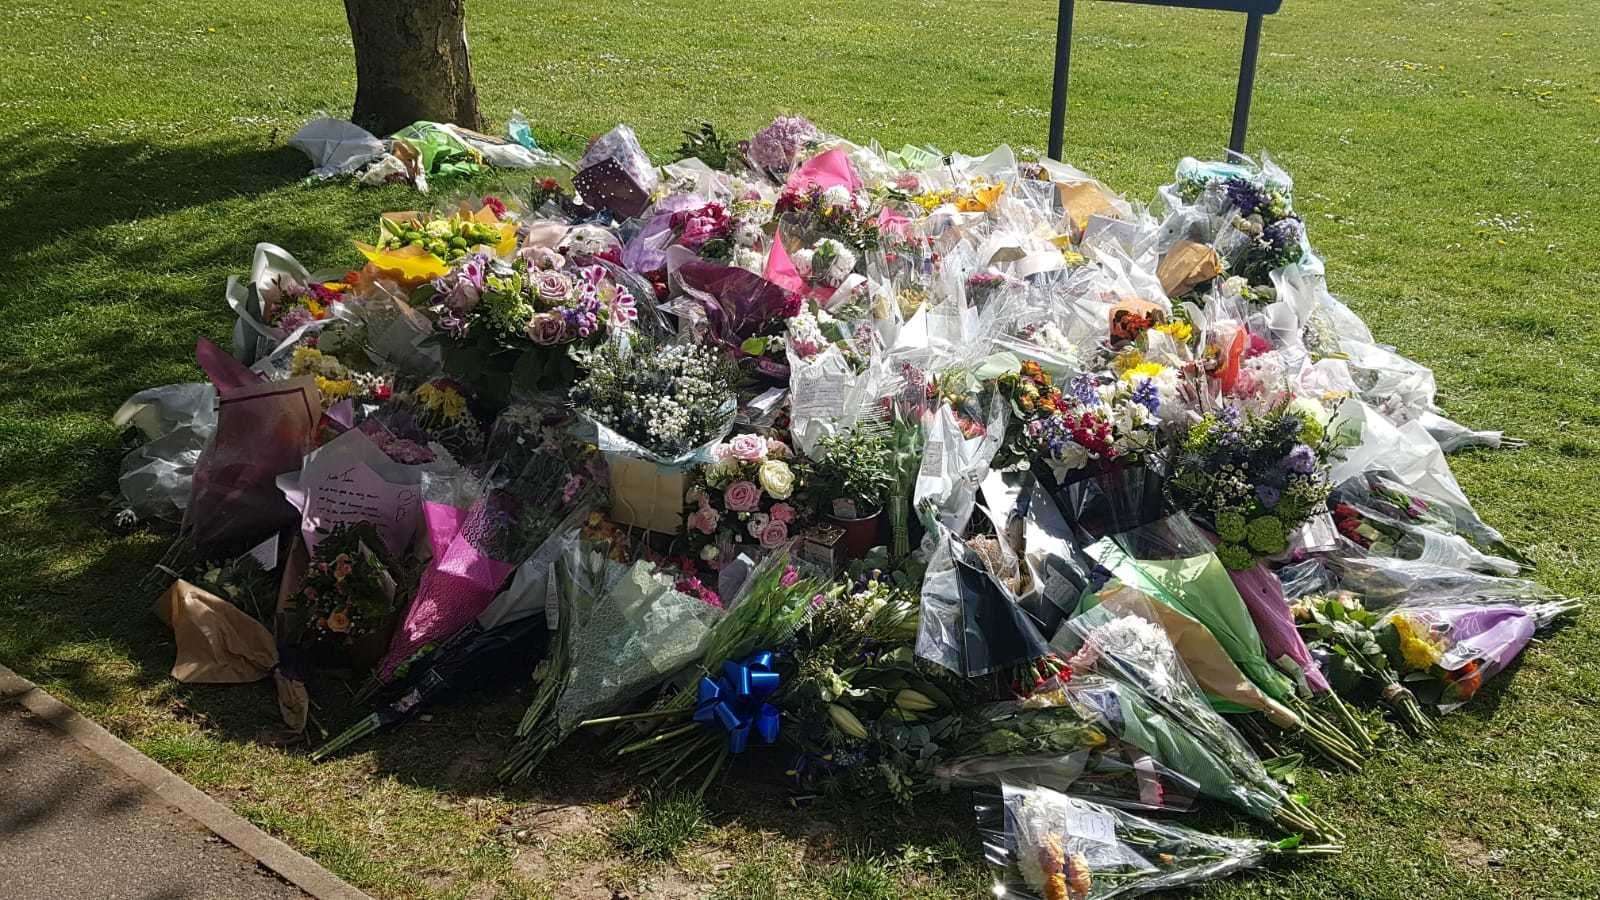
xmin=568 ymin=338 xmax=738 ymax=535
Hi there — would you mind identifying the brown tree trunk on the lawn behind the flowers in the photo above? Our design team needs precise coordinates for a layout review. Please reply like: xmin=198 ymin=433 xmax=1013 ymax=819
xmin=344 ymin=0 xmax=483 ymax=135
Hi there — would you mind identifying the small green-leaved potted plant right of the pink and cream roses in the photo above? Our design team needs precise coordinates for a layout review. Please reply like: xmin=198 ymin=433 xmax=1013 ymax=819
xmin=806 ymin=429 xmax=894 ymax=559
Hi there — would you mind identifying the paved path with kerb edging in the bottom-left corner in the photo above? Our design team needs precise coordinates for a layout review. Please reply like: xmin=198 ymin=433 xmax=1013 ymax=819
xmin=0 ymin=666 xmax=371 ymax=900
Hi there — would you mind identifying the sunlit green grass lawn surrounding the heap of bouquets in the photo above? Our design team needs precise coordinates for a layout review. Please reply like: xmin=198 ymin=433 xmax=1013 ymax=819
xmin=0 ymin=0 xmax=1600 ymax=900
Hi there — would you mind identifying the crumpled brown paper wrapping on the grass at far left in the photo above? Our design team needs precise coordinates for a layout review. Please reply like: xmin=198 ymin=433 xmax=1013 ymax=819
xmin=155 ymin=580 xmax=278 ymax=684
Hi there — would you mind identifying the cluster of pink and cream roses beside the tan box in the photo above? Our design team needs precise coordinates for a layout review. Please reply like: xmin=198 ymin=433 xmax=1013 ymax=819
xmin=685 ymin=434 xmax=800 ymax=569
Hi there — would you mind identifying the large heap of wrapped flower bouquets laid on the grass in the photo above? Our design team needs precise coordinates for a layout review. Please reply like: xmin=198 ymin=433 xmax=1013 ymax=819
xmin=122 ymin=117 xmax=1571 ymax=900
